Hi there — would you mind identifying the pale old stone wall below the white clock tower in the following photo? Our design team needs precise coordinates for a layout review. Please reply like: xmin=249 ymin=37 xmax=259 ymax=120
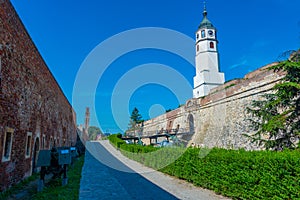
xmin=143 ymin=63 xmax=283 ymax=150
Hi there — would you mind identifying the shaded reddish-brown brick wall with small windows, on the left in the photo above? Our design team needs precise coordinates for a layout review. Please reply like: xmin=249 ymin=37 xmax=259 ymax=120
xmin=0 ymin=0 xmax=76 ymax=191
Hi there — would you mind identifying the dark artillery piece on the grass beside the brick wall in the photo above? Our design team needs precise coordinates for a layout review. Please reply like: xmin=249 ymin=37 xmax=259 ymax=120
xmin=37 ymin=147 xmax=77 ymax=191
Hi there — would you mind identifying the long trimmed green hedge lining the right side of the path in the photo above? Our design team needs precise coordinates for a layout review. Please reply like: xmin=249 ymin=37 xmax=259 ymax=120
xmin=110 ymin=136 xmax=300 ymax=199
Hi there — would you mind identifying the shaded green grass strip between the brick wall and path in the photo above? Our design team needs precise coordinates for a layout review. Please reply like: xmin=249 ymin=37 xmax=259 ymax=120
xmin=32 ymin=156 xmax=84 ymax=200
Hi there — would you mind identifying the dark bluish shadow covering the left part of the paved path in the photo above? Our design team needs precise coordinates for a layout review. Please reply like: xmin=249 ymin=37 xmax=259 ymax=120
xmin=79 ymin=142 xmax=177 ymax=200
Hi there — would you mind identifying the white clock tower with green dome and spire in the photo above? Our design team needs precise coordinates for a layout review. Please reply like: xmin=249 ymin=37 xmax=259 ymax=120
xmin=193 ymin=6 xmax=225 ymax=98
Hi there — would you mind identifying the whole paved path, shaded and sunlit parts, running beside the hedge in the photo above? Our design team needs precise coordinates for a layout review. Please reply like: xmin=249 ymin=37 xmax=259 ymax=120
xmin=79 ymin=141 xmax=229 ymax=200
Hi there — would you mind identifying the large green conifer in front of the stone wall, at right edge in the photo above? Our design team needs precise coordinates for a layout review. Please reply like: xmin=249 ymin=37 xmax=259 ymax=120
xmin=248 ymin=50 xmax=300 ymax=150
